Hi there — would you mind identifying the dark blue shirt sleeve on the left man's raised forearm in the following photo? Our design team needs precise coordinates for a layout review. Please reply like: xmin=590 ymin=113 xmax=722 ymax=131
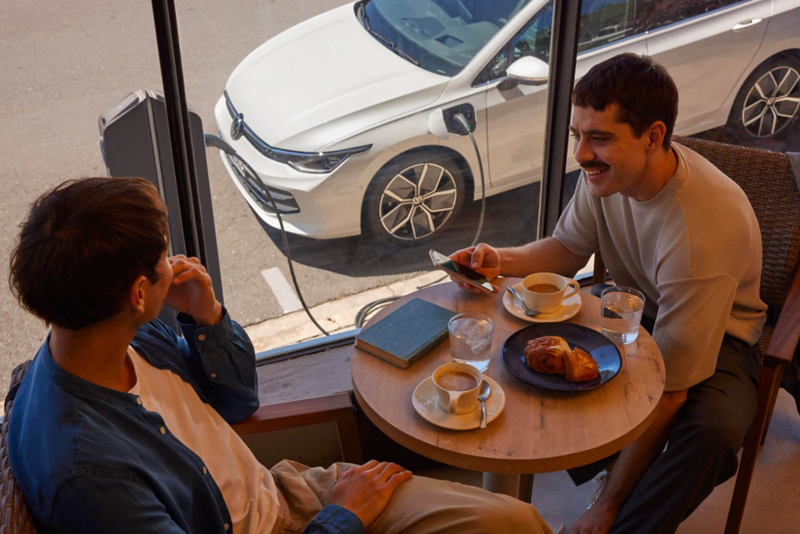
xmin=175 ymin=308 xmax=259 ymax=423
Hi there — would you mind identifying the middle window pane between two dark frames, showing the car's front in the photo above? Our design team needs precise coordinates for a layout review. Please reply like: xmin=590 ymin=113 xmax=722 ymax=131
xmin=173 ymin=0 xmax=552 ymax=358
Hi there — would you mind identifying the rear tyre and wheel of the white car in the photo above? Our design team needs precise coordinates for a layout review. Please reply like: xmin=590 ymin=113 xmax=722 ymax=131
xmin=728 ymin=55 xmax=800 ymax=139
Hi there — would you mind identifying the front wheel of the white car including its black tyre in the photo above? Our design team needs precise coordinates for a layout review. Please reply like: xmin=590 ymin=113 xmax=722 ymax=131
xmin=362 ymin=153 xmax=466 ymax=246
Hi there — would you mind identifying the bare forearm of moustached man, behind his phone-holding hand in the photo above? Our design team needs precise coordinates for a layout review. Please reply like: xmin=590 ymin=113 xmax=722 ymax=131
xmin=498 ymin=237 xmax=589 ymax=278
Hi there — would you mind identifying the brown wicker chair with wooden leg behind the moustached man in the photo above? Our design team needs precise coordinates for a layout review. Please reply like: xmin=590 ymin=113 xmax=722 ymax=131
xmin=592 ymin=137 xmax=800 ymax=534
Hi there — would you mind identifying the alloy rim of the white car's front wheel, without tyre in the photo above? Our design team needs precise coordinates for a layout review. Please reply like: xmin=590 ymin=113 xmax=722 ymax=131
xmin=378 ymin=163 xmax=460 ymax=240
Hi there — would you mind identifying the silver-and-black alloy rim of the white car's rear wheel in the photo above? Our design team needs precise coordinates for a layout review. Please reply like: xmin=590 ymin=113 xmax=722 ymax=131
xmin=741 ymin=66 xmax=800 ymax=138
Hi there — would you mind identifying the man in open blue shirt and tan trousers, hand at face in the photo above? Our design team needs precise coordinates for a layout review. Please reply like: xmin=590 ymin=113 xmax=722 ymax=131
xmin=8 ymin=178 xmax=550 ymax=534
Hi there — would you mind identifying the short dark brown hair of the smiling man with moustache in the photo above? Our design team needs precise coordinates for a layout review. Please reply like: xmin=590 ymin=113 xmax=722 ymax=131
xmin=572 ymin=53 xmax=678 ymax=150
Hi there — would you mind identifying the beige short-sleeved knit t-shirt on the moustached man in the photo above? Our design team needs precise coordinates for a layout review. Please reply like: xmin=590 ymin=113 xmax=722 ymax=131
xmin=553 ymin=143 xmax=767 ymax=391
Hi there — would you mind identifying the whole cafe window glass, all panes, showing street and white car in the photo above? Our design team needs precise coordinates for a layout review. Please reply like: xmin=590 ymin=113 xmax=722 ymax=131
xmin=0 ymin=0 xmax=800 ymax=390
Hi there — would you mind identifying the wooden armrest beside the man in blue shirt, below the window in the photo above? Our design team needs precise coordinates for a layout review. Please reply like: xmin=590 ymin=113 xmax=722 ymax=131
xmin=231 ymin=393 xmax=355 ymax=436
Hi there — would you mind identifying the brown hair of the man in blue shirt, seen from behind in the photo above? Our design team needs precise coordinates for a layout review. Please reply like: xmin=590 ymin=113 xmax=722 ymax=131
xmin=8 ymin=178 xmax=168 ymax=330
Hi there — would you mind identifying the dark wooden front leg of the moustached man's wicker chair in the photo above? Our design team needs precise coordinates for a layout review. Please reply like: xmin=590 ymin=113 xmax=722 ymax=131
xmin=725 ymin=367 xmax=780 ymax=534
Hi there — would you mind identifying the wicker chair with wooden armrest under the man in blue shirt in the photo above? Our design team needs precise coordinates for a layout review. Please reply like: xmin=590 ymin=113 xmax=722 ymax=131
xmin=0 ymin=360 xmax=364 ymax=534
